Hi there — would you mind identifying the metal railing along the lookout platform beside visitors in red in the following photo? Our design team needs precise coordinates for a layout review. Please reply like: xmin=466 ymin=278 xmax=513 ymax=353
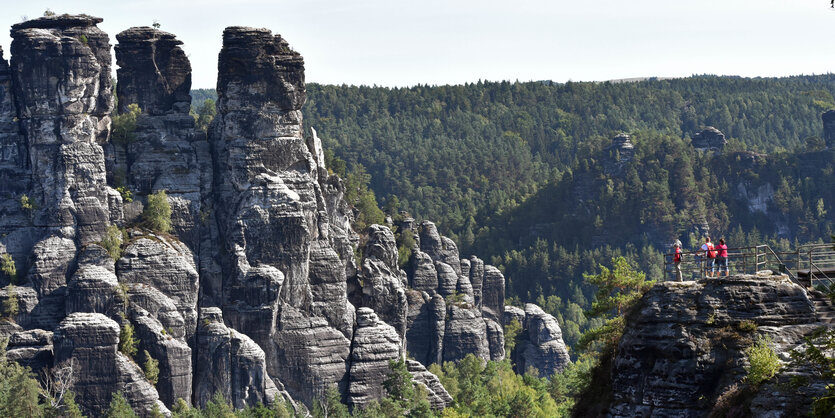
xmin=664 ymin=244 xmax=835 ymax=287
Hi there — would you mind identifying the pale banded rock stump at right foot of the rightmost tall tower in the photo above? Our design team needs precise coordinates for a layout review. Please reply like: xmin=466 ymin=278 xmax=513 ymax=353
xmin=347 ymin=308 xmax=401 ymax=407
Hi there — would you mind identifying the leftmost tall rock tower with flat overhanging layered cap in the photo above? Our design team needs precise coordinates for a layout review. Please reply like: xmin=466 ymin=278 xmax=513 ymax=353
xmin=10 ymin=15 xmax=121 ymax=244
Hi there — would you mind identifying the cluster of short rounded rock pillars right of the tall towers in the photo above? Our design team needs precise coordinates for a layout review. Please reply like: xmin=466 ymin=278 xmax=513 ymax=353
xmin=406 ymin=221 xmax=505 ymax=365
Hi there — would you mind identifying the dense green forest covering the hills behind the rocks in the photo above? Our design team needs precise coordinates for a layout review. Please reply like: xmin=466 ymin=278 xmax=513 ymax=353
xmin=194 ymin=74 xmax=835 ymax=346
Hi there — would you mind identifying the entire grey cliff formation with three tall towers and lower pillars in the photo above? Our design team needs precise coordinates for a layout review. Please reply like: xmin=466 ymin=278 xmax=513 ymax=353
xmin=0 ymin=15 xmax=572 ymax=416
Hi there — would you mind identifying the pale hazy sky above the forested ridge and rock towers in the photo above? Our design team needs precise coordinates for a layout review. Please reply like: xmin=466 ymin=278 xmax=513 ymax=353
xmin=0 ymin=0 xmax=835 ymax=87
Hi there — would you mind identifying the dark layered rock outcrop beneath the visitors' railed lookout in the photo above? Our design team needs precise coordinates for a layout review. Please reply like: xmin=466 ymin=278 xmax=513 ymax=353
xmin=609 ymin=274 xmax=816 ymax=417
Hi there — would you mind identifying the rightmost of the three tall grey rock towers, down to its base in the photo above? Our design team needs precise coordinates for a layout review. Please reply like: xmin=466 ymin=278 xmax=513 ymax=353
xmin=209 ymin=27 xmax=353 ymax=404
